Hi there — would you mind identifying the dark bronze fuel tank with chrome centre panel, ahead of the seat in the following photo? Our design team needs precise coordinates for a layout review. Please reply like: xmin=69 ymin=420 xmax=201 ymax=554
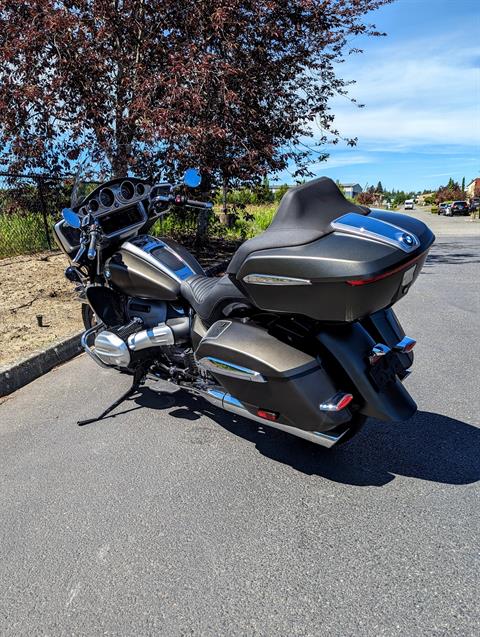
xmin=105 ymin=235 xmax=204 ymax=301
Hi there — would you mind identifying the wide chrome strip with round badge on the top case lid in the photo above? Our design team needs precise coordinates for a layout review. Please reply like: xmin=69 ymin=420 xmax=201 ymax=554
xmin=330 ymin=212 xmax=420 ymax=252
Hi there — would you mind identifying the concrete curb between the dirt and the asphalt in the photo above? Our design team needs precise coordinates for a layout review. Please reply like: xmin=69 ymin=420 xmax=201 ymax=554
xmin=0 ymin=331 xmax=83 ymax=398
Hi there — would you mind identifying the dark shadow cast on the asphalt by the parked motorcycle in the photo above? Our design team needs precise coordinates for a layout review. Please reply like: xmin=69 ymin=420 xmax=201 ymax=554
xmin=124 ymin=387 xmax=480 ymax=486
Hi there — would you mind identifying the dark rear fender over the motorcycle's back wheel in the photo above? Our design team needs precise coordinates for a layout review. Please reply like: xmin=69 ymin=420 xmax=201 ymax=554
xmin=317 ymin=323 xmax=417 ymax=421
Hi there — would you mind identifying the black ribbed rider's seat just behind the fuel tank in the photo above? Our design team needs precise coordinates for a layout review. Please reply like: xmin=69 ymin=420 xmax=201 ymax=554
xmin=180 ymin=274 xmax=251 ymax=323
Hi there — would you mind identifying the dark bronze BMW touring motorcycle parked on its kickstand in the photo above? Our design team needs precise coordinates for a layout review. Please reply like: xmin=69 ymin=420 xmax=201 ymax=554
xmin=55 ymin=169 xmax=435 ymax=448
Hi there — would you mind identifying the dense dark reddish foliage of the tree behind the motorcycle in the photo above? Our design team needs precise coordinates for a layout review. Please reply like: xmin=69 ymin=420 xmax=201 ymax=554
xmin=0 ymin=0 xmax=388 ymax=187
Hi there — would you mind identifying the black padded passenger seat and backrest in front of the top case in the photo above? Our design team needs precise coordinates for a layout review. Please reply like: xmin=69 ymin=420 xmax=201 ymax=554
xmin=227 ymin=177 xmax=370 ymax=275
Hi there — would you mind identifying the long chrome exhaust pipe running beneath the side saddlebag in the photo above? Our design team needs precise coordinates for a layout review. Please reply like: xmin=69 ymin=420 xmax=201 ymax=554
xmin=194 ymin=389 xmax=349 ymax=449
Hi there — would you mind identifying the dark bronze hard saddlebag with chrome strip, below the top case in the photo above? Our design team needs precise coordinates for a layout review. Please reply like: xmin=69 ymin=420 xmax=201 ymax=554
xmin=195 ymin=320 xmax=352 ymax=432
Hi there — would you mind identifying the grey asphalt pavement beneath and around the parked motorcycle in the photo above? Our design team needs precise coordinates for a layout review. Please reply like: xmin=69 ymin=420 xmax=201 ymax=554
xmin=0 ymin=238 xmax=480 ymax=636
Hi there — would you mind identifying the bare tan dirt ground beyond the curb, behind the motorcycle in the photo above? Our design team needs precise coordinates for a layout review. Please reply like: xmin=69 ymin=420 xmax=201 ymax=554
xmin=0 ymin=237 xmax=239 ymax=367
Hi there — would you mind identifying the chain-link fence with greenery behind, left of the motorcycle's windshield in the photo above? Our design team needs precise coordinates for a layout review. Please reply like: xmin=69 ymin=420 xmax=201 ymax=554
xmin=0 ymin=172 xmax=72 ymax=258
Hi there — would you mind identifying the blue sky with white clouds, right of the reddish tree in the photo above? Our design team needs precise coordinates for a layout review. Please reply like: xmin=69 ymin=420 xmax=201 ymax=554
xmin=278 ymin=0 xmax=480 ymax=190
